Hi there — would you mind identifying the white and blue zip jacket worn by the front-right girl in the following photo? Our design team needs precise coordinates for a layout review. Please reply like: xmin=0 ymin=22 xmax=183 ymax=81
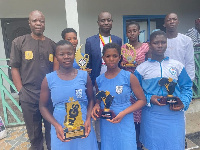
xmin=134 ymin=57 xmax=192 ymax=110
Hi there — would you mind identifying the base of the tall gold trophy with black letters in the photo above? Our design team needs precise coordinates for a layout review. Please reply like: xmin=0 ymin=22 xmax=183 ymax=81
xmin=64 ymin=126 xmax=85 ymax=140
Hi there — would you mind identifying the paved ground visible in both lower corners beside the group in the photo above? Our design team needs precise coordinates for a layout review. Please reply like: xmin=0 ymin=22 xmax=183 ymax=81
xmin=0 ymin=100 xmax=200 ymax=150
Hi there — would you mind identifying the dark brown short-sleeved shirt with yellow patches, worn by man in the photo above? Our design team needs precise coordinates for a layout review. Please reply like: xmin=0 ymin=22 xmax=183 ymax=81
xmin=10 ymin=34 xmax=55 ymax=103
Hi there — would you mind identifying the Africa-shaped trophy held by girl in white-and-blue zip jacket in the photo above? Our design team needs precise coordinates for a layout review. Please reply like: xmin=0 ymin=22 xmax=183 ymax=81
xmin=159 ymin=78 xmax=178 ymax=104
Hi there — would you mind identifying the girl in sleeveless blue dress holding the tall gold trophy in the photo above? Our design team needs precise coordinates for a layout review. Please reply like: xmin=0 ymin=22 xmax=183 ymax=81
xmin=40 ymin=40 xmax=98 ymax=150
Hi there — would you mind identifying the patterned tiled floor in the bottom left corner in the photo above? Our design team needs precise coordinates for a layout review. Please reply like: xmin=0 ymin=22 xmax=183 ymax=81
xmin=0 ymin=126 xmax=30 ymax=150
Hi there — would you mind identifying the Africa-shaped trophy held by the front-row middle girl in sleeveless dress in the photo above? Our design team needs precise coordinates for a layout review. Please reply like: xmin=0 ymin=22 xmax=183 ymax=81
xmin=96 ymin=91 xmax=115 ymax=119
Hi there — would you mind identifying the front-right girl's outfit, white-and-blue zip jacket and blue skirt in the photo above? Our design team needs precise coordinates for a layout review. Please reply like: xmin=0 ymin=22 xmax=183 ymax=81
xmin=134 ymin=57 xmax=192 ymax=150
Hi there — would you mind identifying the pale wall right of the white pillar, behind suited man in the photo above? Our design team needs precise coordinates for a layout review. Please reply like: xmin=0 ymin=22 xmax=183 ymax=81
xmin=77 ymin=0 xmax=200 ymax=44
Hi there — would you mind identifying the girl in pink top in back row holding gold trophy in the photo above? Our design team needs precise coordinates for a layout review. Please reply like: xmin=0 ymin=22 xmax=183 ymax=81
xmin=121 ymin=21 xmax=150 ymax=150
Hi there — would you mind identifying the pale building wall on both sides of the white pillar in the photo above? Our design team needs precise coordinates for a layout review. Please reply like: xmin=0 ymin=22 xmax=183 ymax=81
xmin=0 ymin=0 xmax=200 ymax=96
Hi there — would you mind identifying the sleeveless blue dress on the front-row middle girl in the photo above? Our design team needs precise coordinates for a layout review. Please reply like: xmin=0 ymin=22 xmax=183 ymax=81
xmin=96 ymin=70 xmax=137 ymax=150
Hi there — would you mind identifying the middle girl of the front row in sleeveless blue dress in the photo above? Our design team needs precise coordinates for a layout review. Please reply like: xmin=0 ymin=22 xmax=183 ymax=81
xmin=92 ymin=43 xmax=146 ymax=150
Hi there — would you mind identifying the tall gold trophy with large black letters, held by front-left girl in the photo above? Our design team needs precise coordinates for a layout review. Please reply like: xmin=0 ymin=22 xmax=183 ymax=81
xmin=64 ymin=97 xmax=85 ymax=140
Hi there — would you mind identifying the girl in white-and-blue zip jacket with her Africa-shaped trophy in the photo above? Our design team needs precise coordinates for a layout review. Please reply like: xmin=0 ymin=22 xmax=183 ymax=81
xmin=134 ymin=31 xmax=192 ymax=150
